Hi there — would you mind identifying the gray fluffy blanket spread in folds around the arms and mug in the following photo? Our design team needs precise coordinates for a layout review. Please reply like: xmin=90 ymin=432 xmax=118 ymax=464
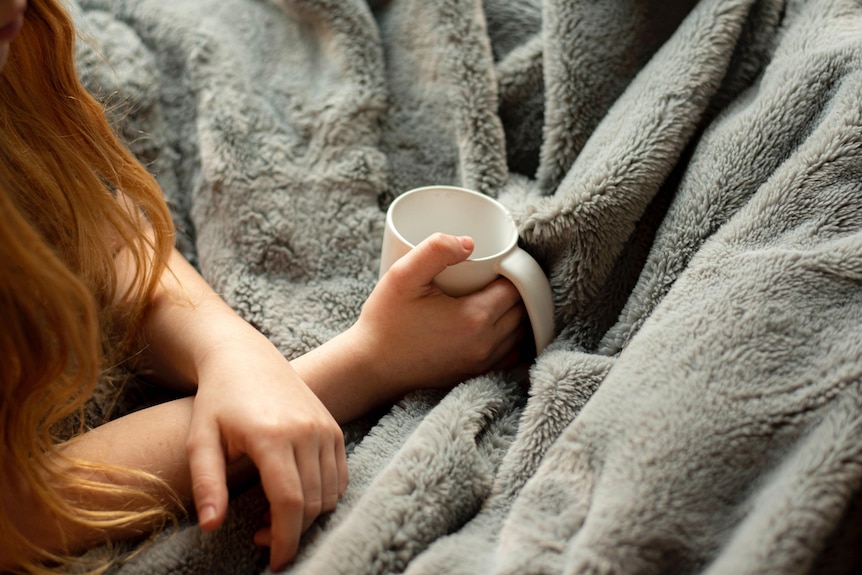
xmin=73 ymin=0 xmax=862 ymax=575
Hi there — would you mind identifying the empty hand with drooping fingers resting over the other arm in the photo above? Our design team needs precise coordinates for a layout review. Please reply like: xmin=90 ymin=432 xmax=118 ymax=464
xmin=187 ymin=328 xmax=347 ymax=570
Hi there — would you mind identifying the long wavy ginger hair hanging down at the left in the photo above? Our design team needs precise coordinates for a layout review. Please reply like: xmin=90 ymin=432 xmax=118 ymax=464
xmin=0 ymin=0 xmax=180 ymax=573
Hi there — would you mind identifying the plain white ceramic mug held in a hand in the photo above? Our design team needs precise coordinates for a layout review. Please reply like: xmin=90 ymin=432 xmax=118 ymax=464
xmin=380 ymin=186 xmax=554 ymax=354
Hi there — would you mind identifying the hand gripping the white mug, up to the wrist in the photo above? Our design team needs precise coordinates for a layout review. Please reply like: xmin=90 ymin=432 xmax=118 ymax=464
xmin=351 ymin=234 xmax=526 ymax=393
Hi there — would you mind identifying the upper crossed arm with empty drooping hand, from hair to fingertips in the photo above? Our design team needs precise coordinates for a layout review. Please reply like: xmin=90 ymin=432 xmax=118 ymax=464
xmin=129 ymin=248 xmax=347 ymax=567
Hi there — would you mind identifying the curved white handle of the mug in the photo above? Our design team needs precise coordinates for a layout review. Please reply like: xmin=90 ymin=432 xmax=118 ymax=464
xmin=497 ymin=247 xmax=554 ymax=355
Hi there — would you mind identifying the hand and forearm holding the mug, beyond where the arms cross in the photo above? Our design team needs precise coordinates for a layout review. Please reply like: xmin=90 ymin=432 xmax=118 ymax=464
xmin=292 ymin=236 xmax=525 ymax=422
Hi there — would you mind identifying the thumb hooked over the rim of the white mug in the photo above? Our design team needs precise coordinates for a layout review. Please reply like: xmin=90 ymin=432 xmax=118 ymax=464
xmin=390 ymin=233 xmax=475 ymax=287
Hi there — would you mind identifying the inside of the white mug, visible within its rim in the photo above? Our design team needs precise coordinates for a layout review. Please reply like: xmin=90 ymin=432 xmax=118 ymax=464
xmin=389 ymin=187 xmax=518 ymax=260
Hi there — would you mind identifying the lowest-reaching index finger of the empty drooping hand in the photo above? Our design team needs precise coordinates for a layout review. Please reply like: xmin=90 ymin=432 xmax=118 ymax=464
xmin=253 ymin=449 xmax=304 ymax=571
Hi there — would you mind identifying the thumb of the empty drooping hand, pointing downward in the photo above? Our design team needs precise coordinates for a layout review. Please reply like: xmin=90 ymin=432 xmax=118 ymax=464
xmin=186 ymin=426 xmax=228 ymax=531
